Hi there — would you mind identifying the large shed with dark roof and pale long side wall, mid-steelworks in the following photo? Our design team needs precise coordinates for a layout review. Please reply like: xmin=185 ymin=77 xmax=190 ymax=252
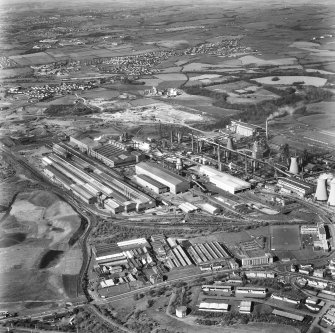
xmin=135 ymin=162 xmax=190 ymax=194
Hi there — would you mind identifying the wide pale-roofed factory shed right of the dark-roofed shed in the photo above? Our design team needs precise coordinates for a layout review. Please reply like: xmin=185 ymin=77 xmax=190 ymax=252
xmin=199 ymin=165 xmax=251 ymax=194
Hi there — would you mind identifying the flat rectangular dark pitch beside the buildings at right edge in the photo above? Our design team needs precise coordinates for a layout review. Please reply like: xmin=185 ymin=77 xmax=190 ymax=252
xmin=270 ymin=225 xmax=301 ymax=251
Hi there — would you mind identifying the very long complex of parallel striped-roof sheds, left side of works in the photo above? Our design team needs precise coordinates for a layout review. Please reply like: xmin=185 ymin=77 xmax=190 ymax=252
xmin=42 ymin=147 xmax=156 ymax=214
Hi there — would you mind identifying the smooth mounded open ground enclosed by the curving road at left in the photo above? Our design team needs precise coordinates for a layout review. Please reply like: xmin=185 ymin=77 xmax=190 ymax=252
xmin=0 ymin=190 xmax=82 ymax=308
